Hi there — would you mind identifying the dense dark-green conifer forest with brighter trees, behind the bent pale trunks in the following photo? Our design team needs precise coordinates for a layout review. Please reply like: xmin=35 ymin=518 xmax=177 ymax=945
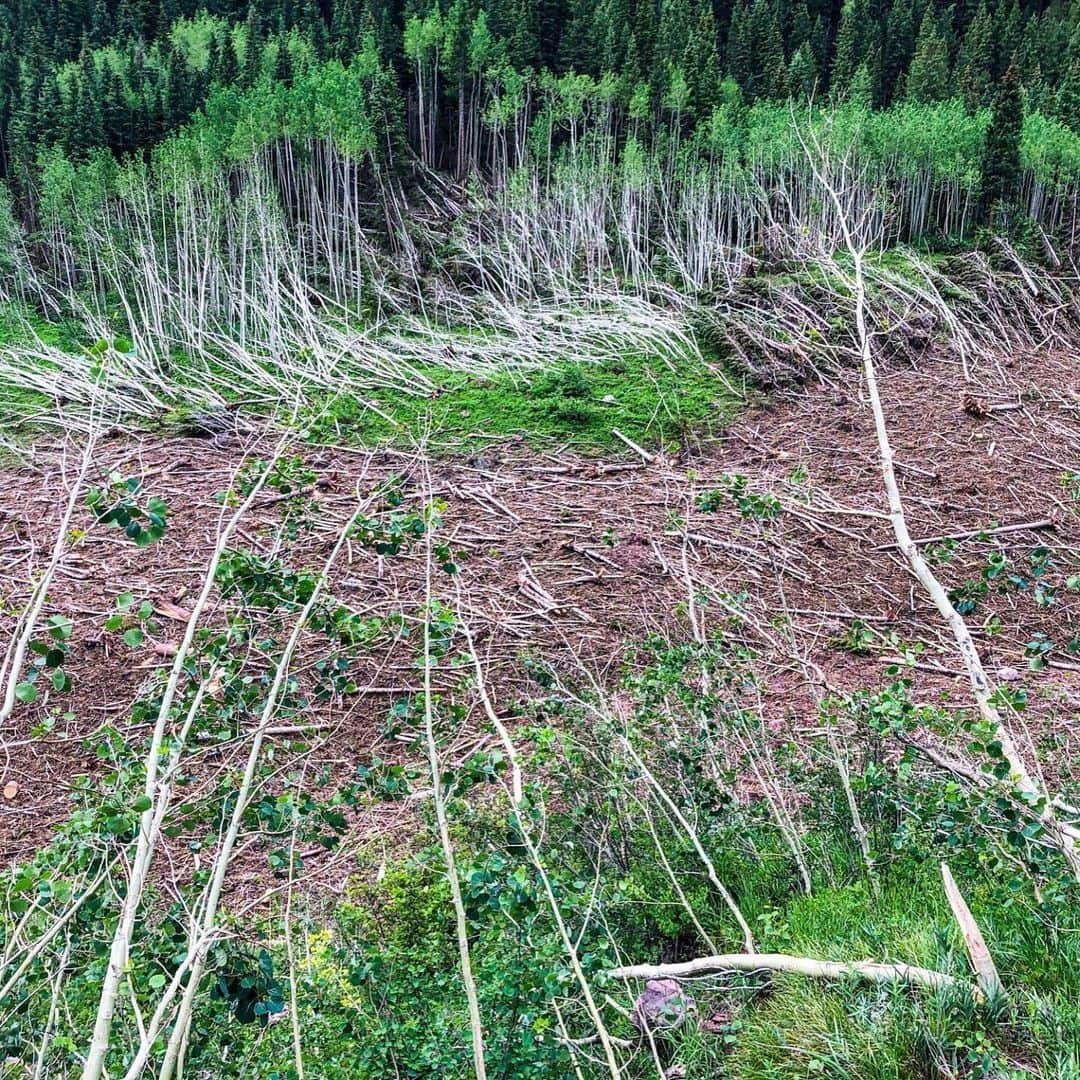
xmin=0 ymin=0 xmax=1080 ymax=227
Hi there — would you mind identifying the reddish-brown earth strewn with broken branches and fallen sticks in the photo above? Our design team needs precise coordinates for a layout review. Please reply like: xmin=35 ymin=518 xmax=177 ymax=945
xmin=0 ymin=345 xmax=1080 ymax=894
